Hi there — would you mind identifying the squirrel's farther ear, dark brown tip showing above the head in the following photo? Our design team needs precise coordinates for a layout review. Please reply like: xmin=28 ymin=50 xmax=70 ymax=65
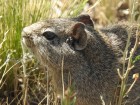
xmin=77 ymin=14 xmax=94 ymax=27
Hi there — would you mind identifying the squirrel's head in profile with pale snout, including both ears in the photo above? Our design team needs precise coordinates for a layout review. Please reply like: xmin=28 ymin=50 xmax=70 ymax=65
xmin=22 ymin=15 xmax=94 ymax=67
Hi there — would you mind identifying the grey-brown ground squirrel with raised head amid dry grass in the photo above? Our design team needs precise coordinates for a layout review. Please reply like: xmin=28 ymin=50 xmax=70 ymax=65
xmin=22 ymin=15 xmax=140 ymax=105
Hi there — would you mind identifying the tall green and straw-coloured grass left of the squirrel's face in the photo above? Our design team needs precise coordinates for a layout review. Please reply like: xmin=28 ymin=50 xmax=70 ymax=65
xmin=0 ymin=0 xmax=87 ymax=105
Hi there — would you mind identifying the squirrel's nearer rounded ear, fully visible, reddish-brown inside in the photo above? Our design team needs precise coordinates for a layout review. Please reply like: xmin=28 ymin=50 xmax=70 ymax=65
xmin=66 ymin=22 xmax=87 ymax=50
